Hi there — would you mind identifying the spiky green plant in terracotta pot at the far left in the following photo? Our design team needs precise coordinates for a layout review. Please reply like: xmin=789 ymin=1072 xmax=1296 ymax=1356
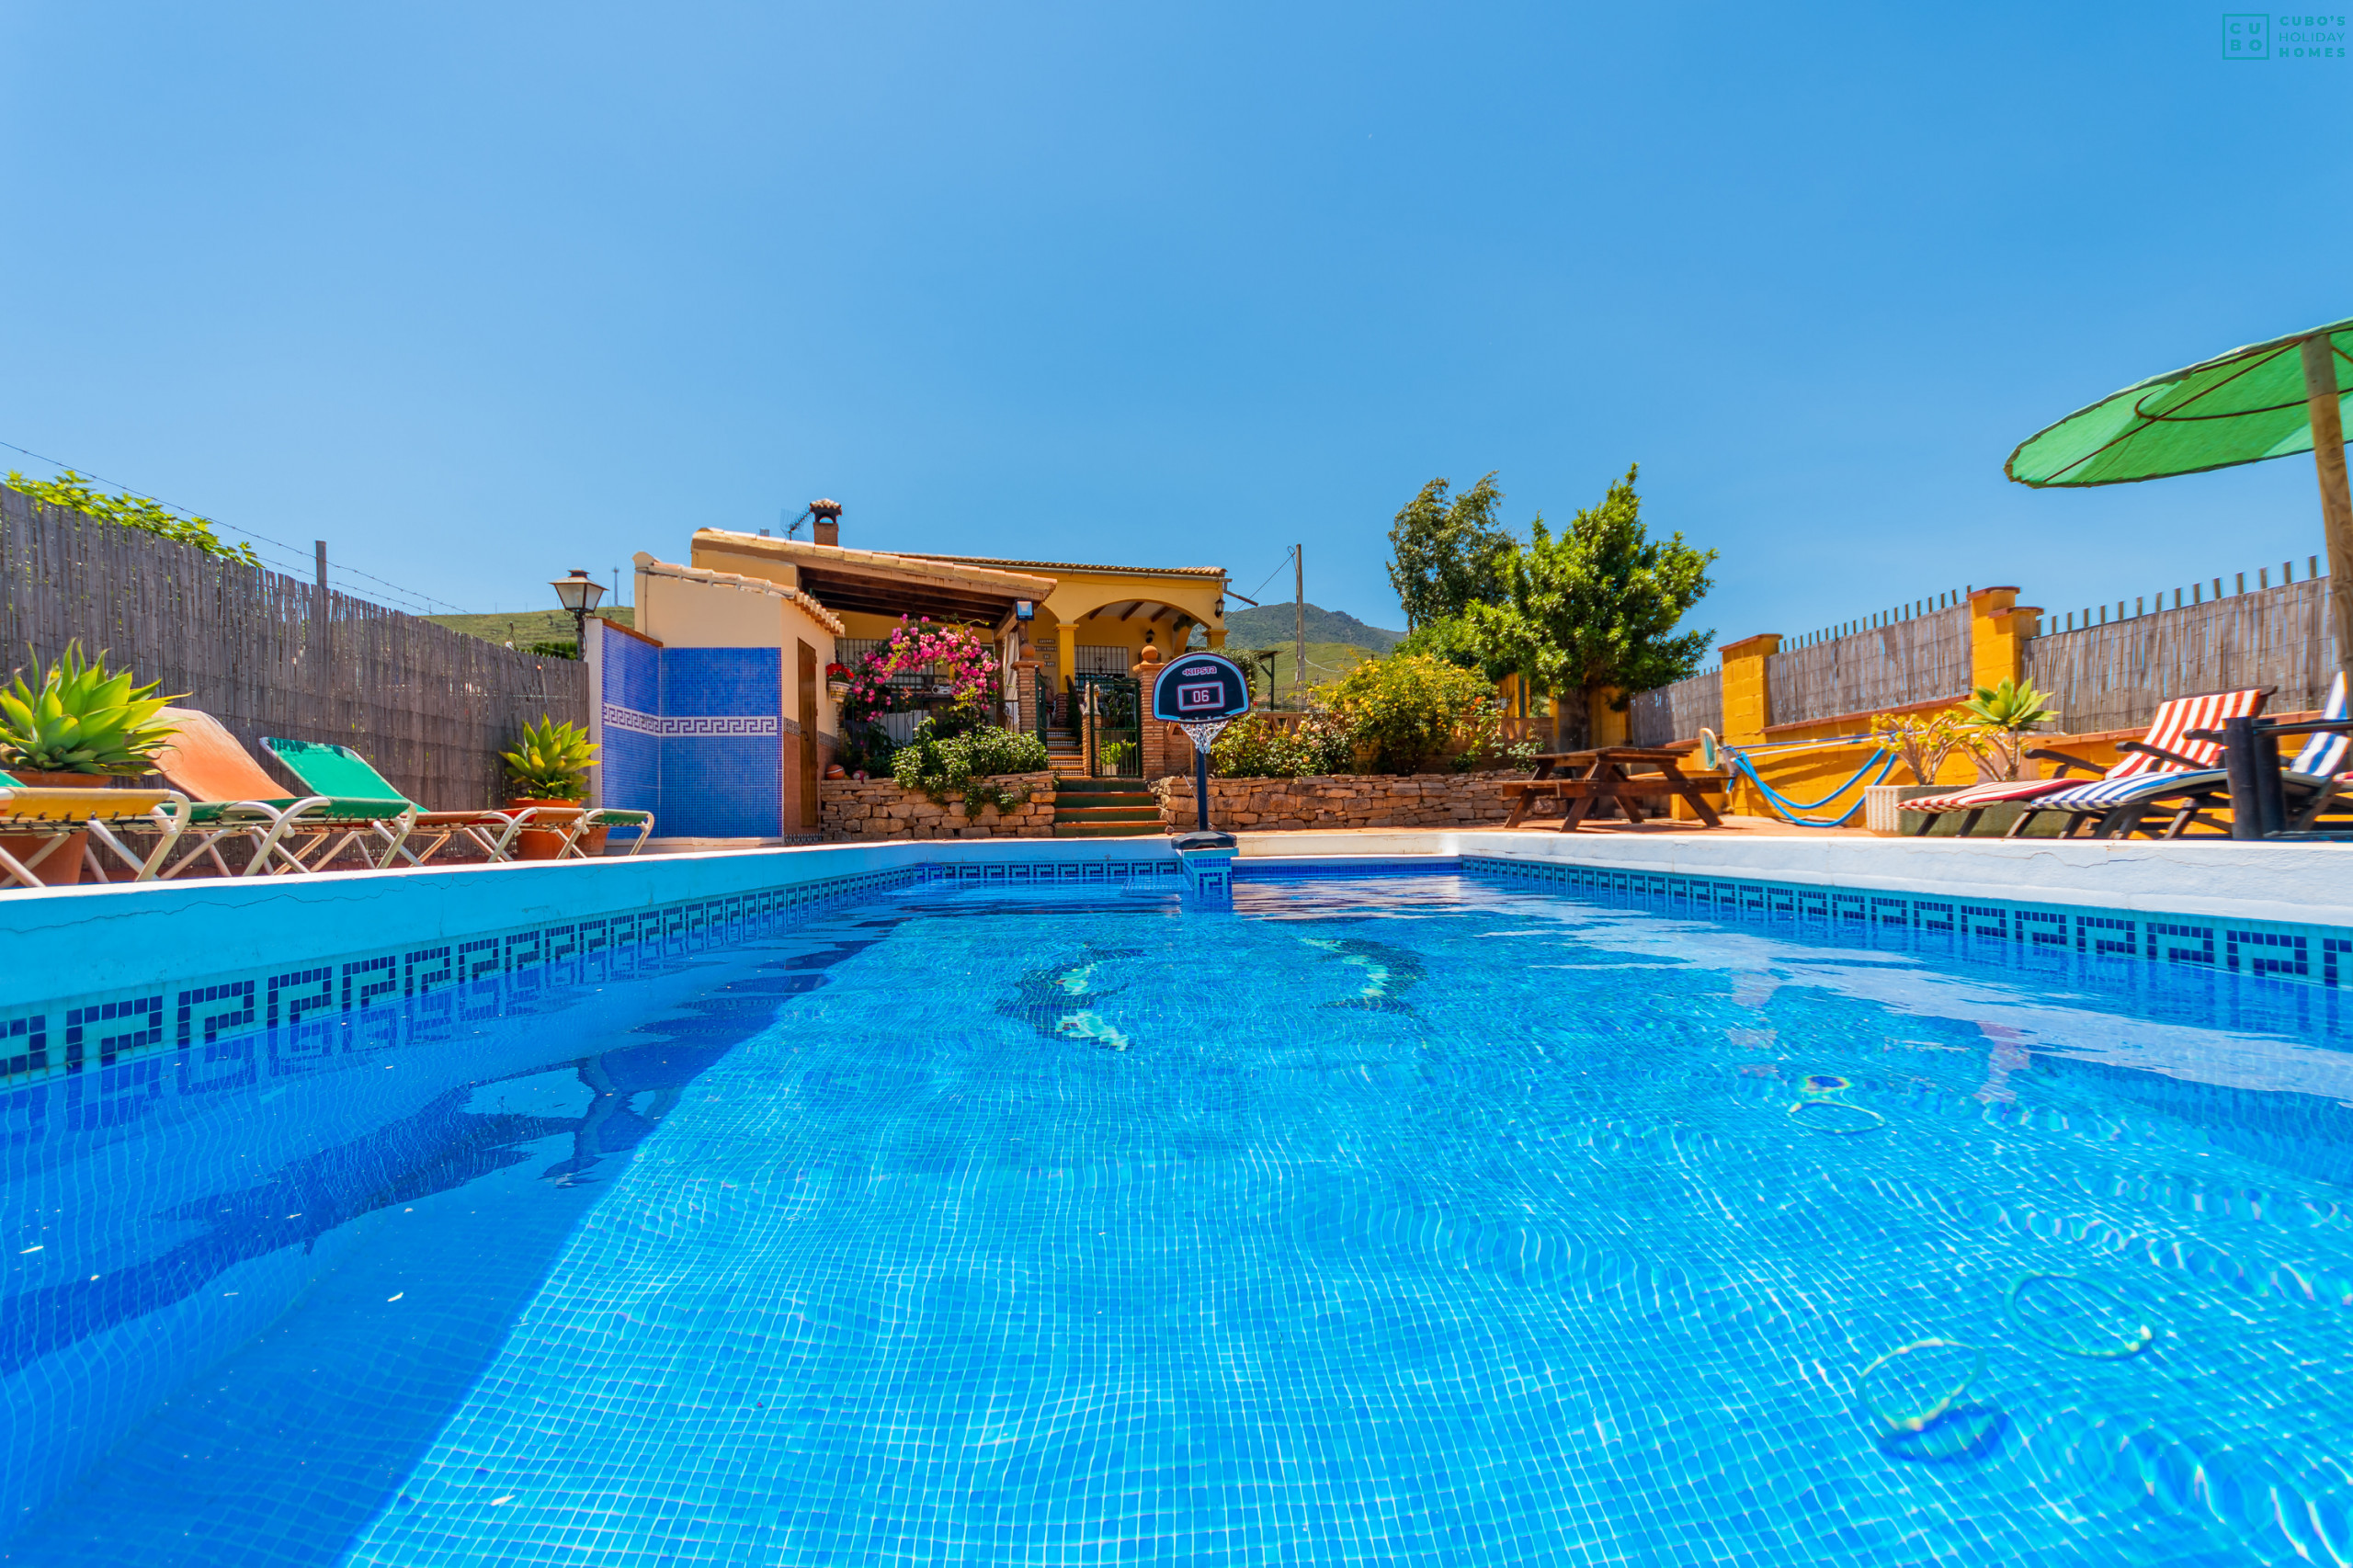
xmin=0 ymin=642 xmax=174 ymax=888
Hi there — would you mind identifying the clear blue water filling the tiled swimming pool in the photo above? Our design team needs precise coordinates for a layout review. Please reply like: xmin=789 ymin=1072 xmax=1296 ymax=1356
xmin=0 ymin=876 xmax=2353 ymax=1568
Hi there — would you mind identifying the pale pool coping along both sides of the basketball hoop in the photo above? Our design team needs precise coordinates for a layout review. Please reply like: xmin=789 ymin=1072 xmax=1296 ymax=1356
xmin=0 ymin=829 xmax=2353 ymax=1007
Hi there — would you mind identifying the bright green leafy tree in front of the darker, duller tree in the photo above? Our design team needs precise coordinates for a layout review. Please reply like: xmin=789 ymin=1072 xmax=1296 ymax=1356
xmin=1463 ymin=469 xmax=1715 ymax=746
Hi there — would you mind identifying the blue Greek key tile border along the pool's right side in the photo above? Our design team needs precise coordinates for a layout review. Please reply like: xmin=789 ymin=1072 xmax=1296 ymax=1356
xmin=1461 ymin=855 xmax=2353 ymax=989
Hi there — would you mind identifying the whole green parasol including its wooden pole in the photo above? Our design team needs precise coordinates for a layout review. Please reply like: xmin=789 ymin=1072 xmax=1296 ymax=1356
xmin=2003 ymin=320 xmax=2353 ymax=668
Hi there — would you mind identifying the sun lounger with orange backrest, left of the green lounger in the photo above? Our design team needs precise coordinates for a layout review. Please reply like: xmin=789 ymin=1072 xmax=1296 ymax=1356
xmin=140 ymin=709 xmax=416 ymax=878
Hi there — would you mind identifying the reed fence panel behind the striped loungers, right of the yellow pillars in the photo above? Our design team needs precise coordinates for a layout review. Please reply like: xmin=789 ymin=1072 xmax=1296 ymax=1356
xmin=2024 ymin=577 xmax=2336 ymax=734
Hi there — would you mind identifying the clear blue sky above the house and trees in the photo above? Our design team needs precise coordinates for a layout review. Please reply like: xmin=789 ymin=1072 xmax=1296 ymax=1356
xmin=0 ymin=0 xmax=2353 ymax=638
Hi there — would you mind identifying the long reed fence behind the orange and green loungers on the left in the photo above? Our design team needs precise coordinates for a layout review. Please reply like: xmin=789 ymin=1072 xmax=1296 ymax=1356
xmin=0 ymin=487 xmax=588 ymax=810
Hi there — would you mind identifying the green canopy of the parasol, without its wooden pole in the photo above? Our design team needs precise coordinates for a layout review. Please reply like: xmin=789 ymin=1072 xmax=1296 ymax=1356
xmin=2003 ymin=320 xmax=2353 ymax=487
